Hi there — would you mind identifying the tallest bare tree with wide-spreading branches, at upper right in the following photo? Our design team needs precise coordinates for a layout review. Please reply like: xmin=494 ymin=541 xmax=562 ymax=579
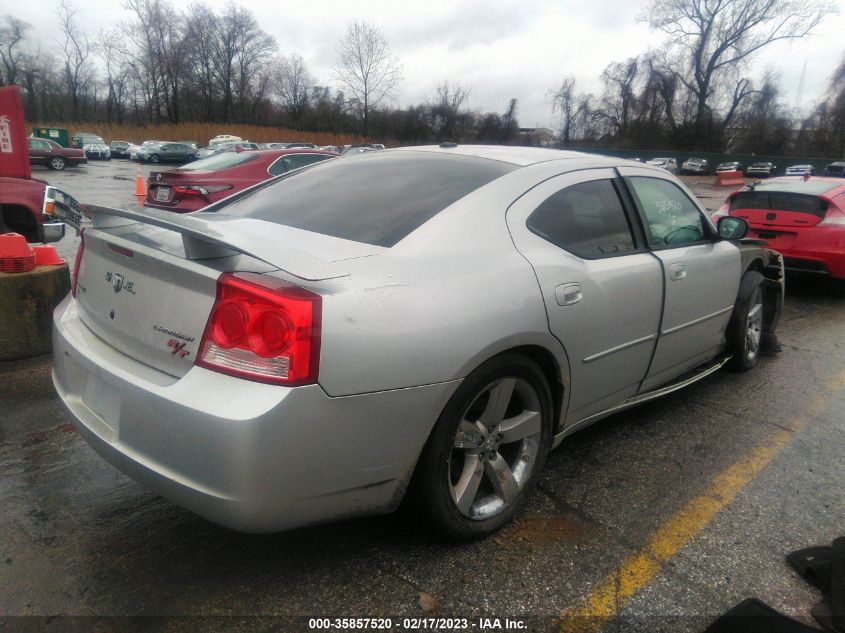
xmin=641 ymin=0 xmax=835 ymax=137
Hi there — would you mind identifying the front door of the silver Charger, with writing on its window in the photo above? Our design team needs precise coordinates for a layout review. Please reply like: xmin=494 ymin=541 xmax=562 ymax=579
xmin=620 ymin=167 xmax=741 ymax=391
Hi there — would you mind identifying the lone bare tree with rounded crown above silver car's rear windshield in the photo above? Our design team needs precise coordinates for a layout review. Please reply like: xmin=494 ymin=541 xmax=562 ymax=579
xmin=334 ymin=20 xmax=402 ymax=136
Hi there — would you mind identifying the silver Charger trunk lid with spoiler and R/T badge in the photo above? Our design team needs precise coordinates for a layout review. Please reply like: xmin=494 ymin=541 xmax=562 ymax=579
xmin=76 ymin=206 xmax=373 ymax=377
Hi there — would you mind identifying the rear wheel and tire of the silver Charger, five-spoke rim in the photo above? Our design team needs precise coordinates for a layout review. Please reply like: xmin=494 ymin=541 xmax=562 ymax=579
xmin=410 ymin=354 xmax=554 ymax=540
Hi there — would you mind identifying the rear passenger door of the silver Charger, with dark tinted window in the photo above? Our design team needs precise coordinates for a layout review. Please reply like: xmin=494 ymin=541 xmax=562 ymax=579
xmin=507 ymin=169 xmax=663 ymax=424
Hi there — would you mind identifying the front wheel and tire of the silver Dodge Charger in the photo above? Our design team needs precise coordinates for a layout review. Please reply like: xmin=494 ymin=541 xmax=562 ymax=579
xmin=725 ymin=270 xmax=766 ymax=371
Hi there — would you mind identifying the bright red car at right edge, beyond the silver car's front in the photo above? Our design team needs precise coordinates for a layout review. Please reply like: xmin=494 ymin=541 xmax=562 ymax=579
xmin=713 ymin=176 xmax=845 ymax=279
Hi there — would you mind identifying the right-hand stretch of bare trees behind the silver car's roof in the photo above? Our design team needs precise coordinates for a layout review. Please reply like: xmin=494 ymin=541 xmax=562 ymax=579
xmin=551 ymin=0 xmax=845 ymax=158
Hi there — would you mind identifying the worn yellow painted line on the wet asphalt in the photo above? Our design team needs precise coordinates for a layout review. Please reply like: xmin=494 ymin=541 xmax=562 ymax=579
xmin=560 ymin=371 xmax=845 ymax=633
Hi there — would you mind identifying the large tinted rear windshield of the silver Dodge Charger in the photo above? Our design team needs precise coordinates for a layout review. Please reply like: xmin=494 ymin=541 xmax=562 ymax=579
xmin=211 ymin=152 xmax=517 ymax=247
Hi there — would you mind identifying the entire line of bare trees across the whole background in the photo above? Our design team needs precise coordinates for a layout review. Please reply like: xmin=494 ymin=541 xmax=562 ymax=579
xmin=0 ymin=0 xmax=845 ymax=157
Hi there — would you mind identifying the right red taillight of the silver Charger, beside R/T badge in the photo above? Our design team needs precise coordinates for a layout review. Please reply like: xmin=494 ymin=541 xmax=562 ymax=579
xmin=197 ymin=273 xmax=322 ymax=386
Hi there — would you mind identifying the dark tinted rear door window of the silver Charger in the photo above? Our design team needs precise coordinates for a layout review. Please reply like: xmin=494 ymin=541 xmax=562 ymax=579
xmin=527 ymin=180 xmax=634 ymax=259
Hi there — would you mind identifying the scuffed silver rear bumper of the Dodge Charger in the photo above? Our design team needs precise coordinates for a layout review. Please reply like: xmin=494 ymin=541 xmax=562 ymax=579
xmin=53 ymin=297 xmax=458 ymax=532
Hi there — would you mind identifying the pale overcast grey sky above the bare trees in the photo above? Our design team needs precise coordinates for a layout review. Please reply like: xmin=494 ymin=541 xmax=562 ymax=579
xmin=6 ymin=0 xmax=845 ymax=128
